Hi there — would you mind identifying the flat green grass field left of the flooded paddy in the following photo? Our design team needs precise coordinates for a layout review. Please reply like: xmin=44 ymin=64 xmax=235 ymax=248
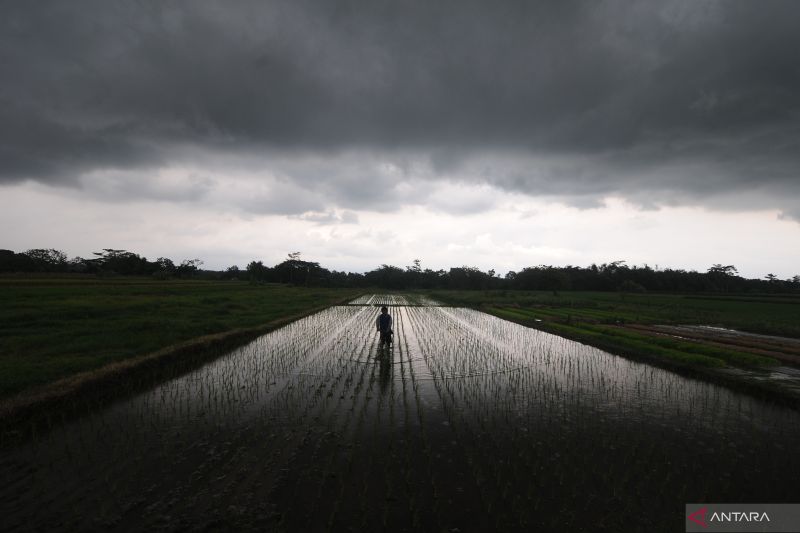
xmin=0 ymin=277 xmax=357 ymax=397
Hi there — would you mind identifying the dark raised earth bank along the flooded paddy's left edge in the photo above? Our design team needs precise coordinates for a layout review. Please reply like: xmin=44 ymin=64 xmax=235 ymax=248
xmin=0 ymin=290 xmax=351 ymax=436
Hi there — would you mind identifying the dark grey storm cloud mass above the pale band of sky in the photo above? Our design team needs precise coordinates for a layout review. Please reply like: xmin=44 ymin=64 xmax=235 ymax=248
xmin=0 ymin=0 xmax=800 ymax=216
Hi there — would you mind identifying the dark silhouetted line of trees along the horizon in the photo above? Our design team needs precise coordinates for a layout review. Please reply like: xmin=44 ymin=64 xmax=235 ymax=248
xmin=0 ymin=248 xmax=800 ymax=293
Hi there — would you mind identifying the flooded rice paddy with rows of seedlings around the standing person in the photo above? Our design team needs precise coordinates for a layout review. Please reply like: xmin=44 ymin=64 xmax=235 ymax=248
xmin=0 ymin=302 xmax=800 ymax=531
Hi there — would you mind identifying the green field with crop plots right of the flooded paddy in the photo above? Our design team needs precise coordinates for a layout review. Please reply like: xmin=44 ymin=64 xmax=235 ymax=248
xmin=432 ymin=291 xmax=800 ymax=367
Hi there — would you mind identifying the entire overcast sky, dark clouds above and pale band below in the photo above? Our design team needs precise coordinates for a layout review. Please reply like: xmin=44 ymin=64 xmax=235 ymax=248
xmin=0 ymin=0 xmax=800 ymax=278
